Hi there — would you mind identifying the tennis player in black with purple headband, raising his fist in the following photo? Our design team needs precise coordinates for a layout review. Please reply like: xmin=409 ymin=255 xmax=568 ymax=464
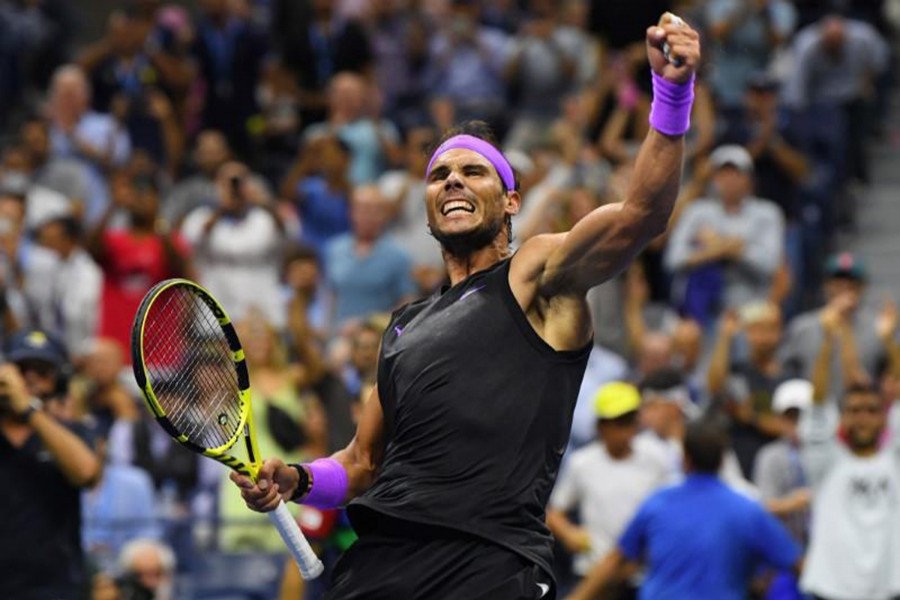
xmin=232 ymin=14 xmax=700 ymax=600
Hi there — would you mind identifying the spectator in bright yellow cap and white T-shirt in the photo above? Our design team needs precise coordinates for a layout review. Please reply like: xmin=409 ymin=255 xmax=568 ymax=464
xmin=547 ymin=382 xmax=669 ymax=593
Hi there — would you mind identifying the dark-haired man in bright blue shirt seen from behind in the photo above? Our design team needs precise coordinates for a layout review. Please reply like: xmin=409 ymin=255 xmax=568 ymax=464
xmin=569 ymin=421 xmax=801 ymax=600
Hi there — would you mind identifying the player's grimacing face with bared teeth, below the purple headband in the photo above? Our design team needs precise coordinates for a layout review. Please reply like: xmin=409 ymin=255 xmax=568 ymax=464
xmin=425 ymin=148 xmax=519 ymax=254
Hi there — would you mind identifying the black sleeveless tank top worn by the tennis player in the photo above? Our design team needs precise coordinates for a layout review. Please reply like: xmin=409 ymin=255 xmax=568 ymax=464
xmin=349 ymin=259 xmax=590 ymax=576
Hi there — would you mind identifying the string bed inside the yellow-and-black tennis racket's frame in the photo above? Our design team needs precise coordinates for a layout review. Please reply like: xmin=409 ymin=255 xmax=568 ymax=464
xmin=144 ymin=287 xmax=241 ymax=448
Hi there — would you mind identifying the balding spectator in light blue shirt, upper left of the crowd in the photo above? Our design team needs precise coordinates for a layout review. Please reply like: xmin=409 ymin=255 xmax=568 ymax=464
xmin=48 ymin=65 xmax=131 ymax=223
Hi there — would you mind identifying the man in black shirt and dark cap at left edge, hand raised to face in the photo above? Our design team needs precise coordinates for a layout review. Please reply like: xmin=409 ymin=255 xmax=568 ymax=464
xmin=0 ymin=330 xmax=100 ymax=600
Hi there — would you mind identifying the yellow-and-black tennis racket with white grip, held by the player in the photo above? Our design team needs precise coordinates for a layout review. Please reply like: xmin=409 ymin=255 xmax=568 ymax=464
xmin=131 ymin=279 xmax=323 ymax=579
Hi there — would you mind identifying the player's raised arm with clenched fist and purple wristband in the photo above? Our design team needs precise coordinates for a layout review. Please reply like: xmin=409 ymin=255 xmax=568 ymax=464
xmin=536 ymin=17 xmax=700 ymax=295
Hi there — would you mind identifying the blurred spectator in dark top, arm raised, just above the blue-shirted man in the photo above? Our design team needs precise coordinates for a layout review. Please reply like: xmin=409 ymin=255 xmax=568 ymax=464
xmin=708 ymin=302 xmax=788 ymax=477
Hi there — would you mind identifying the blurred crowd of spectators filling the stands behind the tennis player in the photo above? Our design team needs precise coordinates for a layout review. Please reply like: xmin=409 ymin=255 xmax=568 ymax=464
xmin=0 ymin=0 xmax=900 ymax=599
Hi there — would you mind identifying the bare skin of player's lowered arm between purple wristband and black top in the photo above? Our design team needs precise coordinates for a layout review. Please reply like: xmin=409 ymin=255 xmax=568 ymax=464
xmin=333 ymin=387 xmax=384 ymax=501
